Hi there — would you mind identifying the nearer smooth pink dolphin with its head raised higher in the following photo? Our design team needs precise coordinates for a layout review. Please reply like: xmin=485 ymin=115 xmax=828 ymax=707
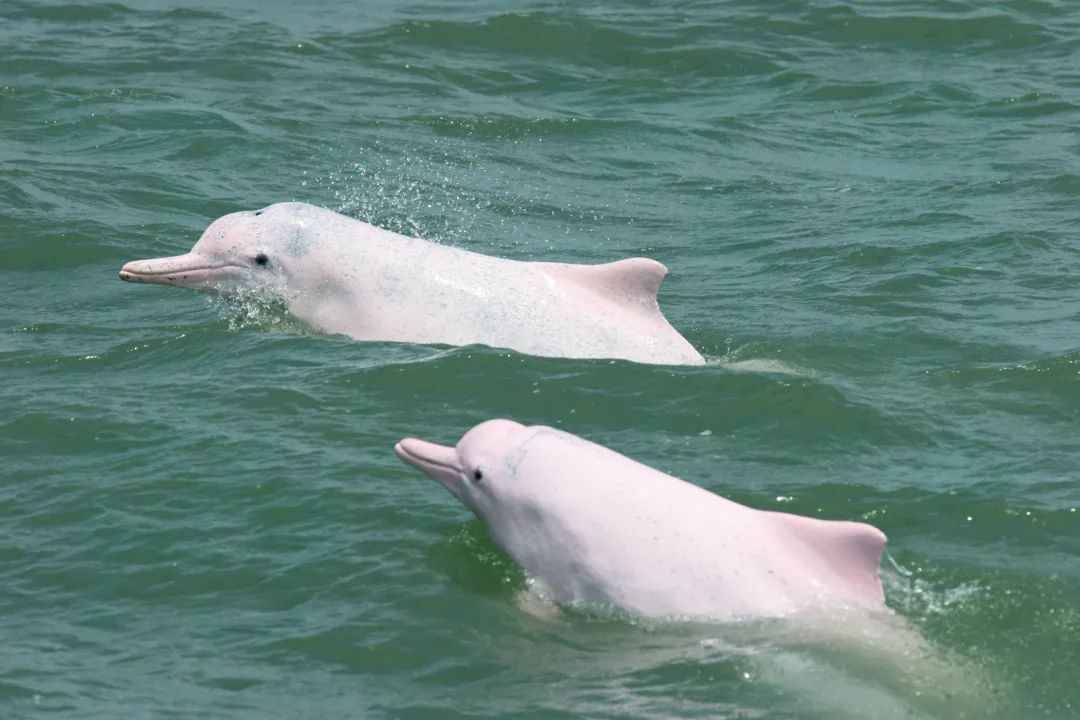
xmin=394 ymin=420 xmax=886 ymax=621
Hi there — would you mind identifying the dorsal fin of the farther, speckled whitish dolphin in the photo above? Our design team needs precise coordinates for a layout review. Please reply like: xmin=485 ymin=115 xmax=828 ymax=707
xmin=539 ymin=258 xmax=667 ymax=312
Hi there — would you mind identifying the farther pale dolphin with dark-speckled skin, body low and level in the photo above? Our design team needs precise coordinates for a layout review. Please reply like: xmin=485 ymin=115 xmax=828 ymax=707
xmin=120 ymin=203 xmax=704 ymax=365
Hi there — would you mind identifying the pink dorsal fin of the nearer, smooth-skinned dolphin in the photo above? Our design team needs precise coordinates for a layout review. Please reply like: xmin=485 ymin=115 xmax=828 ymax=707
xmin=771 ymin=513 xmax=886 ymax=606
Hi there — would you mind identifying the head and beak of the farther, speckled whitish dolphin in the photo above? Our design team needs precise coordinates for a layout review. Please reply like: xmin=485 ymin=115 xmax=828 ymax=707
xmin=120 ymin=203 xmax=328 ymax=297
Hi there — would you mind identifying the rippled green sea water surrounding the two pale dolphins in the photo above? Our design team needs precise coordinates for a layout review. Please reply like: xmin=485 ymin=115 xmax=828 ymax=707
xmin=0 ymin=0 xmax=1080 ymax=719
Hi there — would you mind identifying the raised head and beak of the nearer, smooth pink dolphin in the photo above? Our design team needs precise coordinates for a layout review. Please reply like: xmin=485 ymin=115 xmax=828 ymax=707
xmin=394 ymin=420 xmax=532 ymax=526
